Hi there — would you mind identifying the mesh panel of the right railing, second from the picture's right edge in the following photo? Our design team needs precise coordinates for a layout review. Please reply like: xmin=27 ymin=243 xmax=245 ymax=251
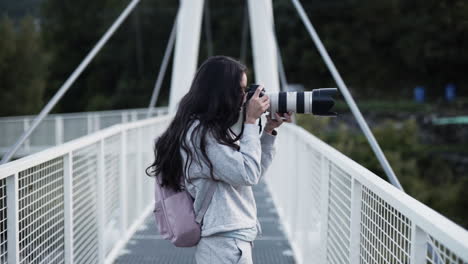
xmin=360 ymin=186 xmax=411 ymax=263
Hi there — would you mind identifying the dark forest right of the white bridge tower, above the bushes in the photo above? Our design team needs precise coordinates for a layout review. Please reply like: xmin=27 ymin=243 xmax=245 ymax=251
xmin=274 ymin=0 xmax=468 ymax=100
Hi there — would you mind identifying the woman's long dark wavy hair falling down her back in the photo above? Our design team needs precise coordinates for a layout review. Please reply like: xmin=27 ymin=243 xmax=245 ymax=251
xmin=146 ymin=56 xmax=247 ymax=191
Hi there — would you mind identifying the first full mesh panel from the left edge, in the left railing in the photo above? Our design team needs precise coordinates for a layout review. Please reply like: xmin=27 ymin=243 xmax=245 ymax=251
xmin=18 ymin=157 xmax=64 ymax=263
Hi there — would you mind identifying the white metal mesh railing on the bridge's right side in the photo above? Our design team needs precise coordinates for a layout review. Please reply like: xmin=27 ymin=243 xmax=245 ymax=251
xmin=266 ymin=124 xmax=468 ymax=264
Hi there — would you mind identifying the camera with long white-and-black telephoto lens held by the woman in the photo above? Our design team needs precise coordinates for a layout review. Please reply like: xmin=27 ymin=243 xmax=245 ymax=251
xmin=246 ymin=84 xmax=338 ymax=117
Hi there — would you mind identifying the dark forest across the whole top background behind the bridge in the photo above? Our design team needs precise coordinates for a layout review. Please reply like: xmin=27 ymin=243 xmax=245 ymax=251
xmin=0 ymin=0 xmax=468 ymax=114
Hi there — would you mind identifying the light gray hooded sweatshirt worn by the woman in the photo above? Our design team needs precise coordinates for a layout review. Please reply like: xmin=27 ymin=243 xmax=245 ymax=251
xmin=181 ymin=121 xmax=275 ymax=236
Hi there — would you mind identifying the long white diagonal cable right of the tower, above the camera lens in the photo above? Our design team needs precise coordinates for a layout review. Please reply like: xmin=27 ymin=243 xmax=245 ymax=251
xmin=291 ymin=0 xmax=403 ymax=190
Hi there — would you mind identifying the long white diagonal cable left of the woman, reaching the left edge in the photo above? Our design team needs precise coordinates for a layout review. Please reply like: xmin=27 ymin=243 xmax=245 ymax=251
xmin=0 ymin=0 xmax=140 ymax=164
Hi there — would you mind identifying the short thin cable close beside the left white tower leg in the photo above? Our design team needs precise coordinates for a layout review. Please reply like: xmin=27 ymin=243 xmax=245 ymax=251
xmin=146 ymin=12 xmax=179 ymax=118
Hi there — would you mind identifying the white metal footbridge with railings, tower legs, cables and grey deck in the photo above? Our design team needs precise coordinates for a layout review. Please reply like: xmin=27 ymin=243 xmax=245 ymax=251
xmin=0 ymin=0 xmax=468 ymax=264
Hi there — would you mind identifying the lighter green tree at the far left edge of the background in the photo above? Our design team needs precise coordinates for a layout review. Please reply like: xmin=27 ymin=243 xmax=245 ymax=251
xmin=0 ymin=17 xmax=48 ymax=116
